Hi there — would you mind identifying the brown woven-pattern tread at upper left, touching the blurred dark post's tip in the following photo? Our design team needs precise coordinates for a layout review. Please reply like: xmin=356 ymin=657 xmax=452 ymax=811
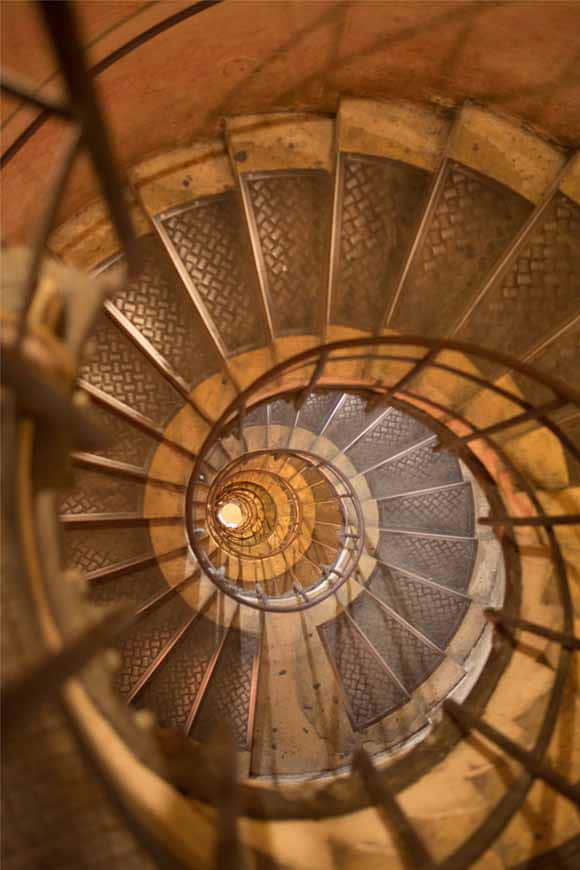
xmin=112 ymin=234 xmax=221 ymax=387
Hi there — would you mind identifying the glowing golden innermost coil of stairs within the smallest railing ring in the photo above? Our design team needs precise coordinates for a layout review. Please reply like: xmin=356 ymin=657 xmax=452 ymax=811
xmin=188 ymin=449 xmax=363 ymax=611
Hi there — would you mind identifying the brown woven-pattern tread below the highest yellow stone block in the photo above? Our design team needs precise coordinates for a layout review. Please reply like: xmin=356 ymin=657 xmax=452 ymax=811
xmin=331 ymin=154 xmax=430 ymax=332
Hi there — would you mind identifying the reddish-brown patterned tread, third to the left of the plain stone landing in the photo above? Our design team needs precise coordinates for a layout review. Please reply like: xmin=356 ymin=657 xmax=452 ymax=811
xmin=114 ymin=595 xmax=191 ymax=697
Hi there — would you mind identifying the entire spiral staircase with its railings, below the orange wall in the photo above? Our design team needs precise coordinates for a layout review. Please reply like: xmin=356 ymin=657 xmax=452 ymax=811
xmin=3 ymin=4 xmax=580 ymax=870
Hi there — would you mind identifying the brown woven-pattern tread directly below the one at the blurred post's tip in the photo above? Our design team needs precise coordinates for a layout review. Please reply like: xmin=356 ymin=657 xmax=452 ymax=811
xmin=80 ymin=312 xmax=183 ymax=424
